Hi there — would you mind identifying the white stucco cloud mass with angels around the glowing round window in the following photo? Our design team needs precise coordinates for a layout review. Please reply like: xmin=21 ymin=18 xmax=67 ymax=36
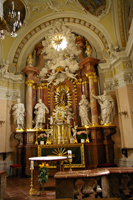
xmin=39 ymin=21 xmax=81 ymax=85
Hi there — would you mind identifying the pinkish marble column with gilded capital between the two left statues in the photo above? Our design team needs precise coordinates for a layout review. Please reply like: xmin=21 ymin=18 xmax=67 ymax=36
xmin=26 ymin=80 xmax=34 ymax=128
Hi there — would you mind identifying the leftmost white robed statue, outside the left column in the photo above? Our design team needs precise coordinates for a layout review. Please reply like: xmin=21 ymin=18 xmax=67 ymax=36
xmin=12 ymin=98 xmax=25 ymax=129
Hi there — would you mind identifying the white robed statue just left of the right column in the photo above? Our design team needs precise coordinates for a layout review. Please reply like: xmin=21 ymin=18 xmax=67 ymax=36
xmin=79 ymin=94 xmax=91 ymax=126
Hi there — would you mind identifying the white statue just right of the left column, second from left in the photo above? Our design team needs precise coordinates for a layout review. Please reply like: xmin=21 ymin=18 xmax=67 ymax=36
xmin=34 ymin=99 xmax=49 ymax=128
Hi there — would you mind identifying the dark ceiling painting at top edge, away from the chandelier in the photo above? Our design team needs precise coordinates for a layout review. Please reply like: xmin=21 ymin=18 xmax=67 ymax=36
xmin=78 ymin=0 xmax=106 ymax=16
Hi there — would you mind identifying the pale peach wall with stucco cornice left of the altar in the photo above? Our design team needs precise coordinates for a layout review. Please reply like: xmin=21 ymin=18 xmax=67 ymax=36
xmin=0 ymin=73 xmax=25 ymax=176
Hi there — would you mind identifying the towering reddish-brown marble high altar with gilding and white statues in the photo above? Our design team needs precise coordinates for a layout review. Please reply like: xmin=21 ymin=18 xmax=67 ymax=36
xmin=15 ymin=21 xmax=116 ymax=175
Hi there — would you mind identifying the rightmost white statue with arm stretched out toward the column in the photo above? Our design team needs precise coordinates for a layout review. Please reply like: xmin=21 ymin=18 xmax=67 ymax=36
xmin=92 ymin=90 xmax=115 ymax=124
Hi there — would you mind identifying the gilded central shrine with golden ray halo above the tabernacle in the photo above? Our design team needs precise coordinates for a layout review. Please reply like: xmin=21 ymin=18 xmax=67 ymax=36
xmin=50 ymin=83 xmax=74 ymax=144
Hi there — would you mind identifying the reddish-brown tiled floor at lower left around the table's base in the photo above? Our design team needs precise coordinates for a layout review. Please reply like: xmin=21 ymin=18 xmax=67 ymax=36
xmin=4 ymin=177 xmax=56 ymax=200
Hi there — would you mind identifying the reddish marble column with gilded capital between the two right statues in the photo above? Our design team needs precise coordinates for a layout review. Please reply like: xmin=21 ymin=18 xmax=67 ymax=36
xmin=86 ymin=72 xmax=98 ymax=125
